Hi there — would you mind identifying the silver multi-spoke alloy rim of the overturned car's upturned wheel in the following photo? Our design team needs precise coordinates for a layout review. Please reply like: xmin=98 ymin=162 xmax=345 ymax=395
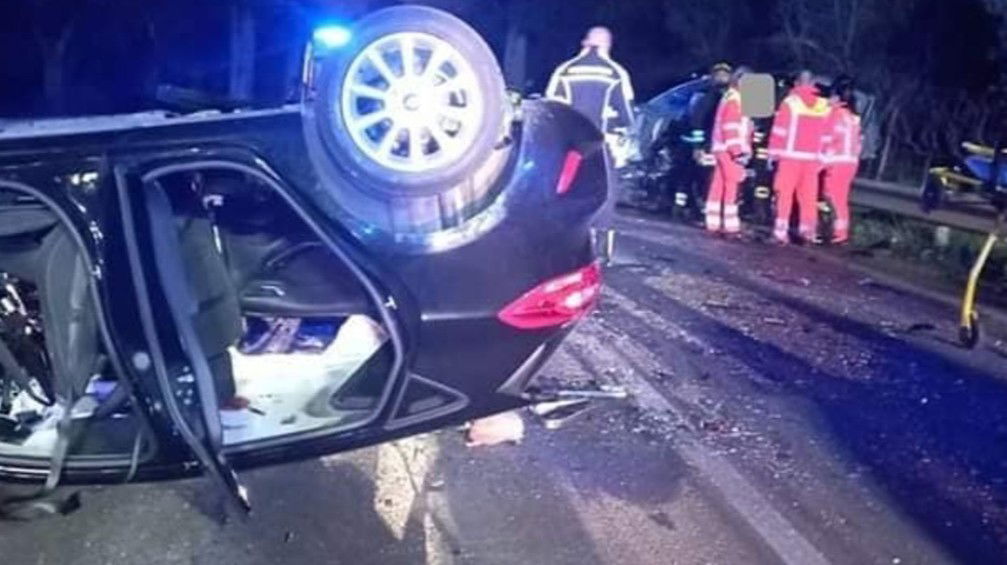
xmin=334 ymin=31 xmax=484 ymax=172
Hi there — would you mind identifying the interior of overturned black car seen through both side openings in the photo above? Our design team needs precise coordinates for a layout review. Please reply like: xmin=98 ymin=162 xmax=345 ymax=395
xmin=0 ymin=171 xmax=394 ymax=456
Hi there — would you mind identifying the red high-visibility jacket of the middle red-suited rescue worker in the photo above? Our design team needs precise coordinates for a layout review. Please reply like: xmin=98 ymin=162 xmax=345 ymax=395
xmin=769 ymin=87 xmax=832 ymax=161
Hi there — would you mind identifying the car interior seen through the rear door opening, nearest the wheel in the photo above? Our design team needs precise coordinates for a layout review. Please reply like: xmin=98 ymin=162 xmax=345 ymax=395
xmin=149 ymin=171 xmax=392 ymax=445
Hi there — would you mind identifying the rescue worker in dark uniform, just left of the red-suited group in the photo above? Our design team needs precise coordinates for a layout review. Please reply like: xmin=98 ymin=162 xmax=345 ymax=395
xmin=675 ymin=62 xmax=733 ymax=220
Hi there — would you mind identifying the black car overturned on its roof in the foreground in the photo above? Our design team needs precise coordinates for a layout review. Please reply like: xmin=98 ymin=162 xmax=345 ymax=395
xmin=0 ymin=7 xmax=607 ymax=511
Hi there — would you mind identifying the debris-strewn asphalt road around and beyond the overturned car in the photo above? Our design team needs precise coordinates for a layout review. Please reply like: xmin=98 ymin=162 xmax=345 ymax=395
xmin=0 ymin=212 xmax=1007 ymax=565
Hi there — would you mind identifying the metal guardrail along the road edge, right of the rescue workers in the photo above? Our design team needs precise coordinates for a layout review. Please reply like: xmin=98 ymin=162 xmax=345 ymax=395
xmin=850 ymin=178 xmax=996 ymax=233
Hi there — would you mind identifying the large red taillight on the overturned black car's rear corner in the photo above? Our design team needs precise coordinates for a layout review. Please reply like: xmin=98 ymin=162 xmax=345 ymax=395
xmin=496 ymin=263 xmax=601 ymax=329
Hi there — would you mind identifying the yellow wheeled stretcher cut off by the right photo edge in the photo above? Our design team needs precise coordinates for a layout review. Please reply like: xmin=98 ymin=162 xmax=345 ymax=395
xmin=923 ymin=139 xmax=1007 ymax=348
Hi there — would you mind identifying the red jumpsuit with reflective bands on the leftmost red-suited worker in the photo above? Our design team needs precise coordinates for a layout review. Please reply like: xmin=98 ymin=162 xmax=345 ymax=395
xmin=706 ymin=87 xmax=752 ymax=234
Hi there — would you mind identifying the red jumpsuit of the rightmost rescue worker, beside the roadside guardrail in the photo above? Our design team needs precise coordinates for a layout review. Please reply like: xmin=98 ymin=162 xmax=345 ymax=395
xmin=825 ymin=103 xmax=863 ymax=244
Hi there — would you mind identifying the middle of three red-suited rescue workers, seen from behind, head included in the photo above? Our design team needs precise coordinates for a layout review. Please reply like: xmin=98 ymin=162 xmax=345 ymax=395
xmin=768 ymin=70 xmax=831 ymax=245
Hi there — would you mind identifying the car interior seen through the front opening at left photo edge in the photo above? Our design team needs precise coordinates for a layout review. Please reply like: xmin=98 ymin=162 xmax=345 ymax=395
xmin=0 ymin=191 xmax=142 ymax=457
